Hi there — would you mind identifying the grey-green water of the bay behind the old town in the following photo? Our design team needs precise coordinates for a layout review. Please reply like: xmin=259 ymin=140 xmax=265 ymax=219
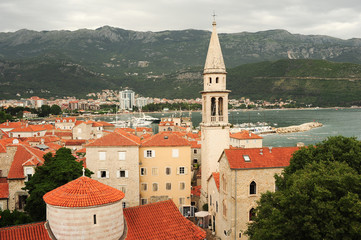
xmin=96 ymin=108 xmax=361 ymax=147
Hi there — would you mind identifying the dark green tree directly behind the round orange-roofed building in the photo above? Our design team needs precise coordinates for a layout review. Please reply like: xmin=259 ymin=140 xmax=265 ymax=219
xmin=24 ymin=148 xmax=92 ymax=221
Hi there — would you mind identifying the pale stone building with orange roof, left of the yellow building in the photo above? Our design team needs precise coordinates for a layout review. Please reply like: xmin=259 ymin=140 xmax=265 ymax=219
xmin=86 ymin=129 xmax=140 ymax=207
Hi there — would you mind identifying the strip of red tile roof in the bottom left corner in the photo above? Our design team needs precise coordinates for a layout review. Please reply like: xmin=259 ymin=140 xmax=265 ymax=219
xmin=0 ymin=222 xmax=51 ymax=240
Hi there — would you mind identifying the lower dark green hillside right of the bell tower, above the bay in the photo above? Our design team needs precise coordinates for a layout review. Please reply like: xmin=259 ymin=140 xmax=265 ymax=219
xmin=227 ymin=60 xmax=361 ymax=106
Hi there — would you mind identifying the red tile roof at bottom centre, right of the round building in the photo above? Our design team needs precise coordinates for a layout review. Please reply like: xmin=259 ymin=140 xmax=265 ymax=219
xmin=124 ymin=200 xmax=206 ymax=240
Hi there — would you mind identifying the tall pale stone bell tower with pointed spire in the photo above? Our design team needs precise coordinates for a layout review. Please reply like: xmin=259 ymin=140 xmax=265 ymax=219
xmin=200 ymin=18 xmax=230 ymax=203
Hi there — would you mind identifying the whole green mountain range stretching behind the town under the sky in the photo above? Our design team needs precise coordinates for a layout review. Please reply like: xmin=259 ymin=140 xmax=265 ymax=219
xmin=0 ymin=26 xmax=361 ymax=105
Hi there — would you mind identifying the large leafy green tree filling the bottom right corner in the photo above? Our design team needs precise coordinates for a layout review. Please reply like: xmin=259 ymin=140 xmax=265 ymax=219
xmin=246 ymin=136 xmax=361 ymax=240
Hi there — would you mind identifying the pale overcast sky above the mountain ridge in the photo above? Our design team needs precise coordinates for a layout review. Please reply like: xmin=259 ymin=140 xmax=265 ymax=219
xmin=0 ymin=0 xmax=361 ymax=39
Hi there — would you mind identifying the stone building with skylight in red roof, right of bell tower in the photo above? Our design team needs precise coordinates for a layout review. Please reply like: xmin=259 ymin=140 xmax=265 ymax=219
xmin=215 ymin=147 xmax=298 ymax=239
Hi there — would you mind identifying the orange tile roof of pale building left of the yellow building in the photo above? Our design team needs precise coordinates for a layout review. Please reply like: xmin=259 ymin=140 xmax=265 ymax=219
xmin=86 ymin=132 xmax=140 ymax=147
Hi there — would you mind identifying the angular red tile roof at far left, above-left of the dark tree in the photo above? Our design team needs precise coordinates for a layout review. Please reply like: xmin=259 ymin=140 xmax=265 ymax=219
xmin=8 ymin=144 xmax=44 ymax=179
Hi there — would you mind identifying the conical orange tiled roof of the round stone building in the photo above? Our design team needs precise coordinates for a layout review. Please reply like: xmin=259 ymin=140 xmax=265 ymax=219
xmin=43 ymin=176 xmax=124 ymax=207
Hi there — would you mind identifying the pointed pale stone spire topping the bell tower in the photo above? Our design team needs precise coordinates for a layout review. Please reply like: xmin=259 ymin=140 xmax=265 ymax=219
xmin=203 ymin=19 xmax=226 ymax=73
